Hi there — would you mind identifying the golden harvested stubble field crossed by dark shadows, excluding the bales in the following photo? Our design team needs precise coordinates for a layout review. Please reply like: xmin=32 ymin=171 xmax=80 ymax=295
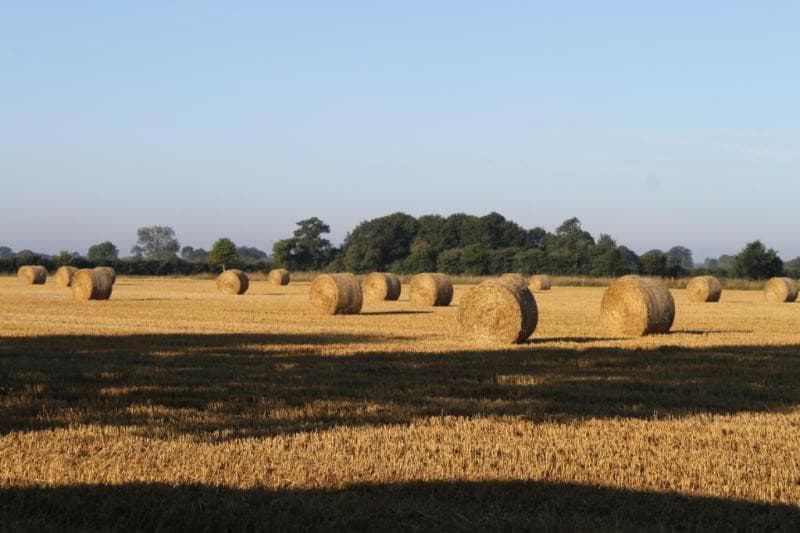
xmin=0 ymin=277 xmax=800 ymax=530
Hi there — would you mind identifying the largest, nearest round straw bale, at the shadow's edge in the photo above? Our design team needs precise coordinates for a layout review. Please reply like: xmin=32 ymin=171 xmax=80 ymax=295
xmin=458 ymin=280 xmax=539 ymax=344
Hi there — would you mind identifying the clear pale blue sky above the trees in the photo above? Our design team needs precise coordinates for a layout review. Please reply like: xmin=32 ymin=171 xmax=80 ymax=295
xmin=0 ymin=1 xmax=800 ymax=260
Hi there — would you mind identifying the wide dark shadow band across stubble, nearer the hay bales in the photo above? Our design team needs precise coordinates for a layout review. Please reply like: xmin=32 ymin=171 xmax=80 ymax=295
xmin=0 ymin=334 xmax=800 ymax=440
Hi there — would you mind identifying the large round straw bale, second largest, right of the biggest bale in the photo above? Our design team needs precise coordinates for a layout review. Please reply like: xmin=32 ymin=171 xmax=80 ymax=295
xmin=600 ymin=276 xmax=675 ymax=336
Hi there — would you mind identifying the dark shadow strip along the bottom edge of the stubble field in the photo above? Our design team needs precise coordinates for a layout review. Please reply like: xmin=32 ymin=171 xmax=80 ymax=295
xmin=0 ymin=481 xmax=800 ymax=531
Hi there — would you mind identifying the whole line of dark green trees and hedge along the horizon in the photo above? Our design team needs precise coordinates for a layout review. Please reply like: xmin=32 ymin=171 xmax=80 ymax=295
xmin=0 ymin=213 xmax=800 ymax=279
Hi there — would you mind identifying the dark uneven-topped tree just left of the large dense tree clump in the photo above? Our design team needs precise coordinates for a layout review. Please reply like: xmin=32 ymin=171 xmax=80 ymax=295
xmin=272 ymin=217 xmax=336 ymax=270
